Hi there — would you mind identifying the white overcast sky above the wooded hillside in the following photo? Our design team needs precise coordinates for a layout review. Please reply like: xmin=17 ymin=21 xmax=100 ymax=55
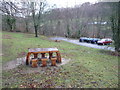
xmin=47 ymin=0 xmax=97 ymax=7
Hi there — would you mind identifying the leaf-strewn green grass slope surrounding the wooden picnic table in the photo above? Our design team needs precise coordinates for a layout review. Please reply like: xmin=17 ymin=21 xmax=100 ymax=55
xmin=2 ymin=32 xmax=119 ymax=88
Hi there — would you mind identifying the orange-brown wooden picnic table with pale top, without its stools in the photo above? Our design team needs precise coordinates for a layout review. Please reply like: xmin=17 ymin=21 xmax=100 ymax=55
xmin=26 ymin=48 xmax=61 ymax=65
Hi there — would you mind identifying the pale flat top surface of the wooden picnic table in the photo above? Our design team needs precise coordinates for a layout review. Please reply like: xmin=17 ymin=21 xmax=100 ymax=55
xmin=29 ymin=48 xmax=58 ymax=52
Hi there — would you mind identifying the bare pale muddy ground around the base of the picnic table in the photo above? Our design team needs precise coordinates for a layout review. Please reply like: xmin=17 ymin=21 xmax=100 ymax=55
xmin=2 ymin=57 xmax=70 ymax=72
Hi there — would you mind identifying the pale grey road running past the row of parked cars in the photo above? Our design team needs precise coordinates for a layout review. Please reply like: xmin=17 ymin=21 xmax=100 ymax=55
xmin=50 ymin=37 xmax=115 ymax=51
